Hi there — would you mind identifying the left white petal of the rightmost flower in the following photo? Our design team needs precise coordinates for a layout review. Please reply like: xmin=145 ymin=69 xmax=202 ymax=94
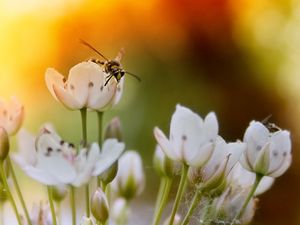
xmin=244 ymin=121 xmax=270 ymax=167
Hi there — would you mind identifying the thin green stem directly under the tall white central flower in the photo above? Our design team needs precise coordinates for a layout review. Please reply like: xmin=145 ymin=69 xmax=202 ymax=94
xmin=169 ymin=164 xmax=188 ymax=225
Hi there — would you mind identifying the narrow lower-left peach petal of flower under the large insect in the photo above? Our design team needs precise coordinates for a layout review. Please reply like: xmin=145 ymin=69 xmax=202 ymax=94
xmin=53 ymin=84 xmax=84 ymax=110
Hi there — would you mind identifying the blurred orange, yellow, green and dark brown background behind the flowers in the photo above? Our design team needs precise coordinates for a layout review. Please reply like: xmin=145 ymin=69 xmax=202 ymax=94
xmin=0 ymin=0 xmax=300 ymax=225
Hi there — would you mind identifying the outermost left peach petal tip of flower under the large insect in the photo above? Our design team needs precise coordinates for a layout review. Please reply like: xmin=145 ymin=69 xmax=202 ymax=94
xmin=45 ymin=68 xmax=64 ymax=101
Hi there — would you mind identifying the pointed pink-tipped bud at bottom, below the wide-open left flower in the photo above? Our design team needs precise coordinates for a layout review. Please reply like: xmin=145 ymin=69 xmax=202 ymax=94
xmin=91 ymin=188 xmax=109 ymax=223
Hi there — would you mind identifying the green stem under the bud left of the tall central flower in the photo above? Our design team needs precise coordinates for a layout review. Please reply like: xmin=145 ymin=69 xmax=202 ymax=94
xmin=153 ymin=178 xmax=172 ymax=225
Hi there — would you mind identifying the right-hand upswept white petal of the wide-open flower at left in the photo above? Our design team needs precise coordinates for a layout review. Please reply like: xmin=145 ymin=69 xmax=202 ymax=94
xmin=93 ymin=139 xmax=125 ymax=176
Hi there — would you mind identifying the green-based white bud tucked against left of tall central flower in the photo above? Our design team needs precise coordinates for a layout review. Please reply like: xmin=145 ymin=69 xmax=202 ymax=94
xmin=153 ymin=145 xmax=176 ymax=178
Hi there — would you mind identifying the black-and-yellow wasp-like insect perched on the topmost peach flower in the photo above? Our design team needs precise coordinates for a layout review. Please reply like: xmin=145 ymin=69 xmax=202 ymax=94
xmin=80 ymin=39 xmax=141 ymax=86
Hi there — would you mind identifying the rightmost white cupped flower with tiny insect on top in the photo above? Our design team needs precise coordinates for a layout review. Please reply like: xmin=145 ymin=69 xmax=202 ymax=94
xmin=240 ymin=121 xmax=292 ymax=177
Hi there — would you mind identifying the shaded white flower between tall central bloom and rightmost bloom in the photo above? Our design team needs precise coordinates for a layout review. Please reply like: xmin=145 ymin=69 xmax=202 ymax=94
xmin=189 ymin=136 xmax=246 ymax=191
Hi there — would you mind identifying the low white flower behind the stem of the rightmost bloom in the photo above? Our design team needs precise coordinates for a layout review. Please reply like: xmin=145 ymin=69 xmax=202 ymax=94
xmin=229 ymin=163 xmax=275 ymax=196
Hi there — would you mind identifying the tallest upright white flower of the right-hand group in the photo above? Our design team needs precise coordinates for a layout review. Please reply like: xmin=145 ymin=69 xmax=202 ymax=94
xmin=154 ymin=105 xmax=218 ymax=167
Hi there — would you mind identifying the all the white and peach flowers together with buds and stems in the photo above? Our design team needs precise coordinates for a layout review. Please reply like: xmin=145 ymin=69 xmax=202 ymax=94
xmin=0 ymin=57 xmax=292 ymax=225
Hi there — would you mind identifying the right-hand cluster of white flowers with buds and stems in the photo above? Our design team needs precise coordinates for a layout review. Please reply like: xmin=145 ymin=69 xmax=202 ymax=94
xmin=153 ymin=105 xmax=291 ymax=225
